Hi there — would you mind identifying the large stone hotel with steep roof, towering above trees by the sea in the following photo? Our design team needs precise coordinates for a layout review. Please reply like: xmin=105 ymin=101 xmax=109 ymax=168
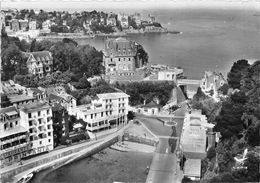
xmin=103 ymin=37 xmax=147 ymax=81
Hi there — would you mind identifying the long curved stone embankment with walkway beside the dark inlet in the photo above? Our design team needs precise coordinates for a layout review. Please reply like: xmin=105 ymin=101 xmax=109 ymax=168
xmin=0 ymin=125 xmax=128 ymax=183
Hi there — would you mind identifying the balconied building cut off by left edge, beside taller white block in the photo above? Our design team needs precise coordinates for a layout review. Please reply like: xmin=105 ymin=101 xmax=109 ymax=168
xmin=0 ymin=106 xmax=31 ymax=167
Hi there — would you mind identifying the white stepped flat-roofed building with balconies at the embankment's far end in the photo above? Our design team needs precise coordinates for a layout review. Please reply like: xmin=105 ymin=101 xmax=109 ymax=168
xmin=76 ymin=93 xmax=129 ymax=137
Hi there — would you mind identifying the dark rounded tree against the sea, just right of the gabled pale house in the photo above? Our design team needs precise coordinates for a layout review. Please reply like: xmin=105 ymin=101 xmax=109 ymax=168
xmin=227 ymin=60 xmax=249 ymax=89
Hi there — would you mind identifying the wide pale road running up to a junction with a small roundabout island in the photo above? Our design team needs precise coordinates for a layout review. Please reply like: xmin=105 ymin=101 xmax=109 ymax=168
xmin=136 ymin=105 xmax=188 ymax=183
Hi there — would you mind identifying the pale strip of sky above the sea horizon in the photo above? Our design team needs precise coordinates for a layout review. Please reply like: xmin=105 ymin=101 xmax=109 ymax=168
xmin=1 ymin=0 xmax=260 ymax=10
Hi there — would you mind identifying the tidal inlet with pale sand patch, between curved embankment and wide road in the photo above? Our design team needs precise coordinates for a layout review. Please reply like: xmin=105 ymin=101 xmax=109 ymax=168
xmin=32 ymin=142 xmax=154 ymax=183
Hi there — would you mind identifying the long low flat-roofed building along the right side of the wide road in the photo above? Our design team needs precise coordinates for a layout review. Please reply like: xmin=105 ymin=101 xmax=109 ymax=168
xmin=180 ymin=111 xmax=214 ymax=180
